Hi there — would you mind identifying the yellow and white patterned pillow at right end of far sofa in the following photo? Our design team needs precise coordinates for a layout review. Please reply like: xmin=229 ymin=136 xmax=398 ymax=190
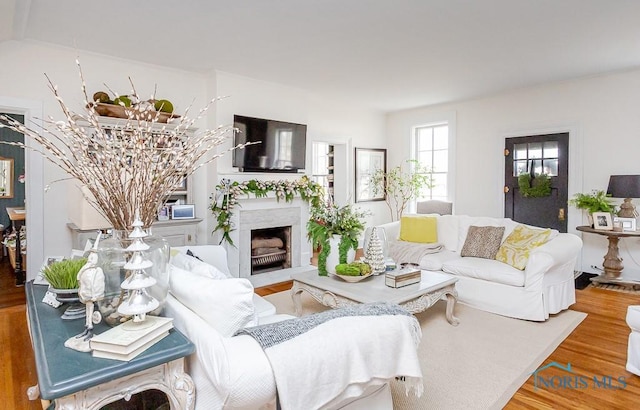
xmin=496 ymin=225 xmax=551 ymax=270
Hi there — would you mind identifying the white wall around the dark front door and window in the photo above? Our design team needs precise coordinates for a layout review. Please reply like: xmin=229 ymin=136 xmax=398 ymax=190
xmin=387 ymin=70 xmax=640 ymax=271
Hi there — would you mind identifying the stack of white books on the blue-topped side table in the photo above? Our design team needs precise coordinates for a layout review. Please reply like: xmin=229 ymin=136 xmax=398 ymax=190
xmin=89 ymin=316 xmax=173 ymax=362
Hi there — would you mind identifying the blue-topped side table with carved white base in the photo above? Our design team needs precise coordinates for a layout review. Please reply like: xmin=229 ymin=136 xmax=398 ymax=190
xmin=25 ymin=282 xmax=195 ymax=410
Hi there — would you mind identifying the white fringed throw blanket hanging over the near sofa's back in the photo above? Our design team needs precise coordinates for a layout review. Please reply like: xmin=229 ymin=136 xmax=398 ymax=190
xmin=238 ymin=302 xmax=423 ymax=410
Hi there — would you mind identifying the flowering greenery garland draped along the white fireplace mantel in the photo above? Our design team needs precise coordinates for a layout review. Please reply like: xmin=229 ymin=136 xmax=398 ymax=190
xmin=210 ymin=176 xmax=323 ymax=246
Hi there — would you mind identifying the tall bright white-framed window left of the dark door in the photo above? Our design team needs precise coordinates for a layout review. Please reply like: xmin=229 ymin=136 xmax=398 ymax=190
xmin=413 ymin=123 xmax=451 ymax=201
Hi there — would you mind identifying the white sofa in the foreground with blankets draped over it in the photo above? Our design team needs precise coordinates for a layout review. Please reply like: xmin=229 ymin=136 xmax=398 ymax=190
xmin=165 ymin=245 xmax=410 ymax=410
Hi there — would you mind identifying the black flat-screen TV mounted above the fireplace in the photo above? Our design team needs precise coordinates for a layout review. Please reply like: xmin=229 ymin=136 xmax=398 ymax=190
xmin=233 ymin=115 xmax=307 ymax=172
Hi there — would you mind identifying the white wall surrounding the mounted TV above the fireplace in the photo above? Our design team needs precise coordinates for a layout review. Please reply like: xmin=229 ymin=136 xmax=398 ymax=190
xmin=216 ymin=72 xmax=388 ymax=231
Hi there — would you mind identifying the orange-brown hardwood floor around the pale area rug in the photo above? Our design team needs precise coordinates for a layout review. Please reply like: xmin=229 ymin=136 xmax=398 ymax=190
xmin=0 ymin=262 xmax=640 ymax=410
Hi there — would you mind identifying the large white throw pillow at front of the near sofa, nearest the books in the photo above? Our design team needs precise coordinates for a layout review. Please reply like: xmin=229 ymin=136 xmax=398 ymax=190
xmin=169 ymin=266 xmax=254 ymax=337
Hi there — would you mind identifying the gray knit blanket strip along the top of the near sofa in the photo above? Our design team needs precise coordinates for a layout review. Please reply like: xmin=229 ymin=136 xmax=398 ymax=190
xmin=236 ymin=302 xmax=412 ymax=349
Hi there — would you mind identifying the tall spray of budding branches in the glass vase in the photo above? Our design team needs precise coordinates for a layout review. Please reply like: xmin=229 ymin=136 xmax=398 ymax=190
xmin=0 ymin=60 xmax=244 ymax=230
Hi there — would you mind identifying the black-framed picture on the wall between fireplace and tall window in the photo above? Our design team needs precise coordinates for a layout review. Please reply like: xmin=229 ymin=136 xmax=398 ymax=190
xmin=355 ymin=148 xmax=387 ymax=202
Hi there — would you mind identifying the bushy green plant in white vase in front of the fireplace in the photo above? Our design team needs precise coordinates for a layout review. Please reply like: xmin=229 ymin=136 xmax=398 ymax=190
xmin=307 ymin=203 xmax=369 ymax=276
